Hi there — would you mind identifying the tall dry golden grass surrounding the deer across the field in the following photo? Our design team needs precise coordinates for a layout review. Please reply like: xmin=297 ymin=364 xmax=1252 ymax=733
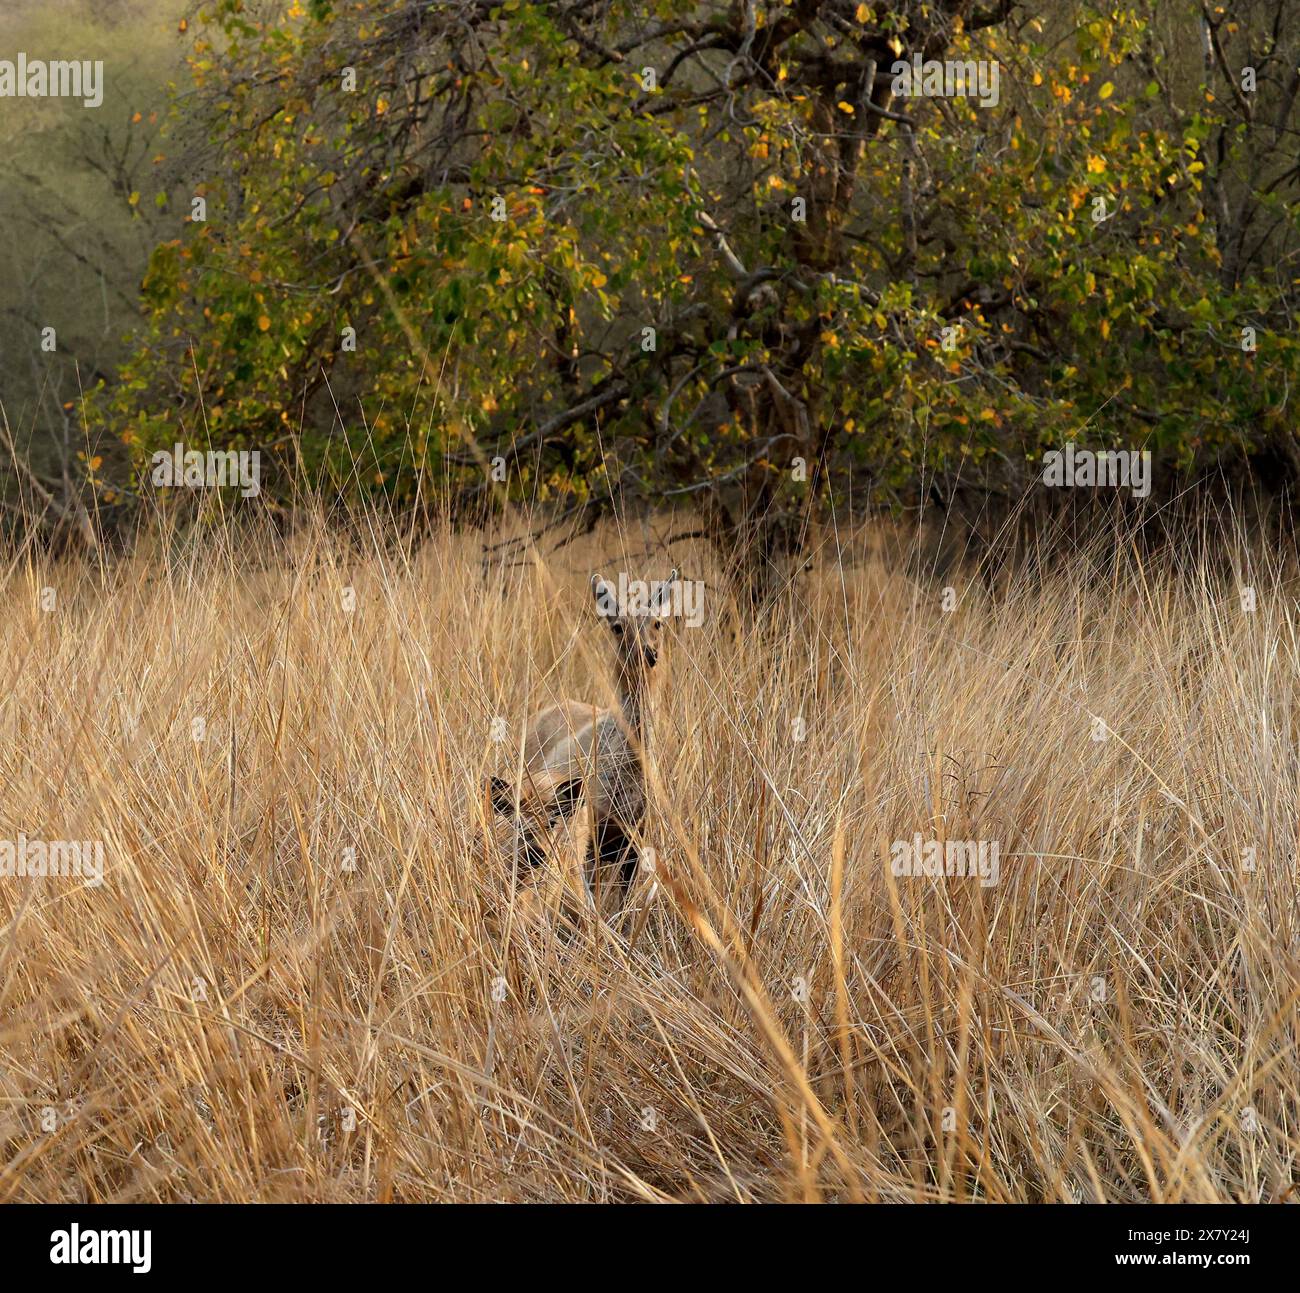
xmin=0 ymin=509 xmax=1300 ymax=1201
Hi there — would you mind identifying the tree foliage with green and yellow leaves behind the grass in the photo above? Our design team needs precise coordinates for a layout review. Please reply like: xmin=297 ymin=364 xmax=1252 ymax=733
xmin=113 ymin=0 xmax=1300 ymax=574
